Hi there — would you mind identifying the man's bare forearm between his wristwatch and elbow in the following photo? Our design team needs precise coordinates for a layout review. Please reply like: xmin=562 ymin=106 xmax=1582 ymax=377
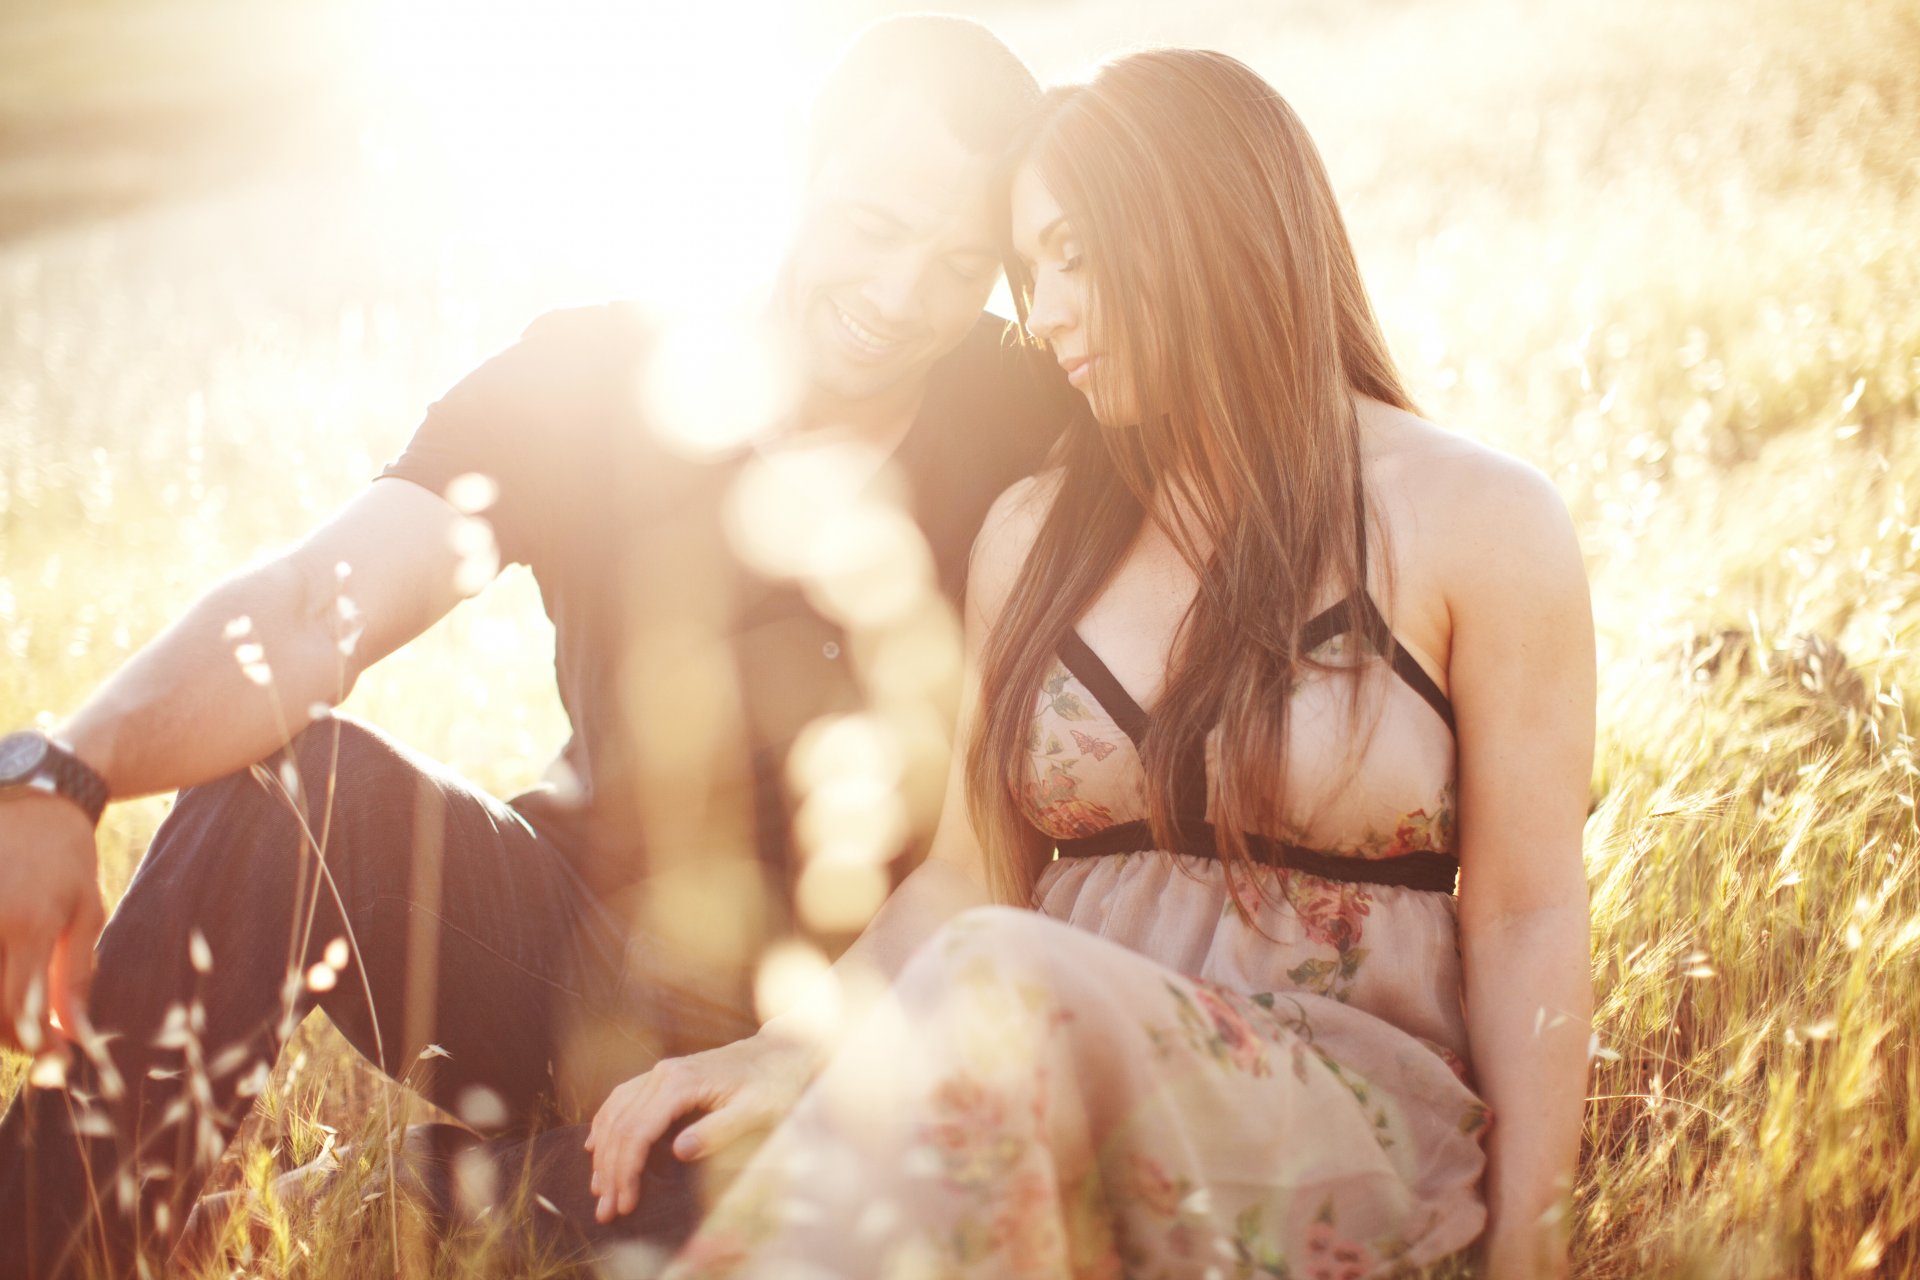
xmin=60 ymin=557 xmax=357 ymax=798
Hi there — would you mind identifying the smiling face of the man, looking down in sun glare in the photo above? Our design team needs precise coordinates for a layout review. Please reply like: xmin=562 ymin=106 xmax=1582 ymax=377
xmin=787 ymin=90 xmax=1000 ymax=410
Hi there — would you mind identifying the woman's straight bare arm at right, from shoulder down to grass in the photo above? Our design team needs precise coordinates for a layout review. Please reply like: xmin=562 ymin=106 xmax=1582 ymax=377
xmin=1446 ymin=459 xmax=1596 ymax=1280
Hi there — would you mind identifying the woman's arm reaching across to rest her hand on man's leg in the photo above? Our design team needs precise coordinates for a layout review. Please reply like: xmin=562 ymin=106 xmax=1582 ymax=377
xmin=586 ymin=480 xmax=1044 ymax=1222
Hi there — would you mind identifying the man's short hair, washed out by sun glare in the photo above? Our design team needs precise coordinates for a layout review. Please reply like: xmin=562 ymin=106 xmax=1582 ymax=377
xmin=808 ymin=13 xmax=1041 ymax=167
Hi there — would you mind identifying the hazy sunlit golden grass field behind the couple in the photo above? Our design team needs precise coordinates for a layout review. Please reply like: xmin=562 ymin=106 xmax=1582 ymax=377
xmin=0 ymin=0 xmax=1920 ymax=1276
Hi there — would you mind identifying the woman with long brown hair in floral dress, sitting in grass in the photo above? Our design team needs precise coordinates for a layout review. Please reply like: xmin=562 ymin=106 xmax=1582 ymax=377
xmin=591 ymin=50 xmax=1594 ymax=1278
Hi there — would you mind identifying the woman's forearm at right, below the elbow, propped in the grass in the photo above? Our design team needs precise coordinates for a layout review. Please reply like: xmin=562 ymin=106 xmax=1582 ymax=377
xmin=1463 ymin=910 xmax=1592 ymax=1276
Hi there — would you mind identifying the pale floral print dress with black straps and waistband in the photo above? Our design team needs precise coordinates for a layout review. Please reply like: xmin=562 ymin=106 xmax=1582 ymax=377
xmin=668 ymin=595 xmax=1488 ymax=1280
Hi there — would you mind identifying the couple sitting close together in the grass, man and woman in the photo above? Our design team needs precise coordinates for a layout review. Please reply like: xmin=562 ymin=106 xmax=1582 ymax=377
xmin=0 ymin=17 xmax=1594 ymax=1280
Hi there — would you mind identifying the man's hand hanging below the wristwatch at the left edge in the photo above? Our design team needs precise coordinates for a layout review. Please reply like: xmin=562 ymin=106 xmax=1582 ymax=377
xmin=0 ymin=794 xmax=106 ymax=1054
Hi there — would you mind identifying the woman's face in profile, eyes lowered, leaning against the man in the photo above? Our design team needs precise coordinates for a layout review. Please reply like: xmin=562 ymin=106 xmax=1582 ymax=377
xmin=1012 ymin=165 xmax=1139 ymax=426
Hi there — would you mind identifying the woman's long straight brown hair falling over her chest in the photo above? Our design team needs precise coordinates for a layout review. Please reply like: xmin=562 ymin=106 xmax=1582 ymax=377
xmin=968 ymin=50 xmax=1413 ymax=912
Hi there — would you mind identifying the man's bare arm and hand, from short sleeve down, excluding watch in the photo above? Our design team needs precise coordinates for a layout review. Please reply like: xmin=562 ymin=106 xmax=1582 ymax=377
xmin=0 ymin=480 xmax=495 ymax=1052
